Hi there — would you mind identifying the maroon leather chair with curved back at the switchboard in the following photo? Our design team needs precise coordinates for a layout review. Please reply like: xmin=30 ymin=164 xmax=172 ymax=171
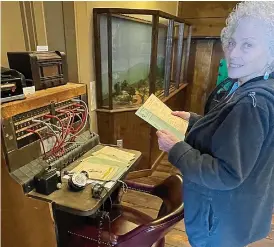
xmin=68 ymin=175 xmax=184 ymax=247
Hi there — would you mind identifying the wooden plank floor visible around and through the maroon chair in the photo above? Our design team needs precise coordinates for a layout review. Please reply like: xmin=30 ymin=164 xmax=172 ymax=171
xmin=122 ymin=157 xmax=274 ymax=247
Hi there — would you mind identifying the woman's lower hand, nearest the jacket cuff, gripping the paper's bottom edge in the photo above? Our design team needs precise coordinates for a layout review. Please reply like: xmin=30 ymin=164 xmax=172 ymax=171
xmin=156 ymin=130 xmax=182 ymax=153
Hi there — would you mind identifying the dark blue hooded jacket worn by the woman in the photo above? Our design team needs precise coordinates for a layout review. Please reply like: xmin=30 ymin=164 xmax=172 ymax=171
xmin=169 ymin=78 xmax=274 ymax=247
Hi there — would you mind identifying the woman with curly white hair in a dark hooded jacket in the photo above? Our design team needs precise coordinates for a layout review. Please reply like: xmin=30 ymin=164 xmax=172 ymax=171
xmin=157 ymin=2 xmax=274 ymax=247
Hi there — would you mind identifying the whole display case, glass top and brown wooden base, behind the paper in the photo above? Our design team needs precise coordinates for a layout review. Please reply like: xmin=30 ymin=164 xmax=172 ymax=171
xmin=93 ymin=8 xmax=191 ymax=176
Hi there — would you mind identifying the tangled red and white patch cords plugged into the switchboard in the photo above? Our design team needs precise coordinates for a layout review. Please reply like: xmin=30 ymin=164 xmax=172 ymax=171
xmin=27 ymin=99 xmax=88 ymax=158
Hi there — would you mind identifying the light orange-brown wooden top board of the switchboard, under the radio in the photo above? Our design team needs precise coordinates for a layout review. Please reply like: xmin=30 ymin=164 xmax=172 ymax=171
xmin=1 ymin=82 xmax=86 ymax=119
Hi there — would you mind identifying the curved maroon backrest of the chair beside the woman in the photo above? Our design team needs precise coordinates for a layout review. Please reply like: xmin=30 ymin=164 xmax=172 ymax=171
xmin=117 ymin=174 xmax=184 ymax=247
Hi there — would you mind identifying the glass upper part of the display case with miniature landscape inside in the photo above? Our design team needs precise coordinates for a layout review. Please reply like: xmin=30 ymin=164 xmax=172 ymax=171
xmin=93 ymin=8 xmax=191 ymax=110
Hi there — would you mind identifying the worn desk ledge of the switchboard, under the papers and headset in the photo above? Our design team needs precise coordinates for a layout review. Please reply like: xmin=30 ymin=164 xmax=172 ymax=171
xmin=28 ymin=145 xmax=141 ymax=216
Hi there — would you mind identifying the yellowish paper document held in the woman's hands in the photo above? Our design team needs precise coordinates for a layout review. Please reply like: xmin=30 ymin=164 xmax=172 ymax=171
xmin=135 ymin=94 xmax=188 ymax=140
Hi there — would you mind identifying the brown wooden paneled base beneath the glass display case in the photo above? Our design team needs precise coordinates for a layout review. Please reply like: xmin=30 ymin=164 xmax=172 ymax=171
xmin=97 ymin=84 xmax=187 ymax=177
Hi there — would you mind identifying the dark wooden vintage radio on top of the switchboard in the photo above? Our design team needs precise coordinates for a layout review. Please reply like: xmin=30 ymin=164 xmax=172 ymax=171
xmin=7 ymin=51 xmax=68 ymax=90
